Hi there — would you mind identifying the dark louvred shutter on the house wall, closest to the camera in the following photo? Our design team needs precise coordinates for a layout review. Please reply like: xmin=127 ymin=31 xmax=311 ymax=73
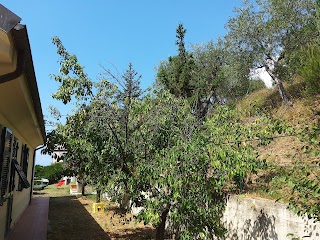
xmin=0 ymin=128 xmax=13 ymax=204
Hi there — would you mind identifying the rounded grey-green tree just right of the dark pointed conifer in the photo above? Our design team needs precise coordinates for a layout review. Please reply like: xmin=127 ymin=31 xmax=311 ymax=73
xmin=192 ymin=39 xmax=255 ymax=107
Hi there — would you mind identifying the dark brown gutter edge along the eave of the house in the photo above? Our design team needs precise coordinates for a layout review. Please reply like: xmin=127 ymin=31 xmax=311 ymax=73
xmin=11 ymin=24 xmax=46 ymax=142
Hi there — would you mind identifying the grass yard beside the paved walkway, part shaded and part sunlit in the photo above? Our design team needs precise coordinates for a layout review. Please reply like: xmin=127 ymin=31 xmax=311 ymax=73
xmin=34 ymin=185 xmax=155 ymax=240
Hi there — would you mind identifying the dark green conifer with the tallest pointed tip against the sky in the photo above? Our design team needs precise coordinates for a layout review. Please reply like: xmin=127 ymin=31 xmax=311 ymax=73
xmin=157 ymin=24 xmax=228 ymax=119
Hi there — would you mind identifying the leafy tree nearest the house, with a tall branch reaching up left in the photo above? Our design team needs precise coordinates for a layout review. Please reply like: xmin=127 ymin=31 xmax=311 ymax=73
xmin=45 ymin=38 xmax=149 ymax=202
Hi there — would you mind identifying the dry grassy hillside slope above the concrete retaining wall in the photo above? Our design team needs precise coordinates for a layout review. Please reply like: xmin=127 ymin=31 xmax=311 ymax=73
xmin=237 ymin=81 xmax=320 ymax=218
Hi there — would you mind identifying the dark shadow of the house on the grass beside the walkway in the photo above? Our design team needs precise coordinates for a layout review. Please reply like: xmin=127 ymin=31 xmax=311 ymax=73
xmin=47 ymin=196 xmax=111 ymax=240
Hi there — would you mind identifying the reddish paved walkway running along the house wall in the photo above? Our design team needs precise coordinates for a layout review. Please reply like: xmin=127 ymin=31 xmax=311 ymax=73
xmin=7 ymin=197 xmax=49 ymax=240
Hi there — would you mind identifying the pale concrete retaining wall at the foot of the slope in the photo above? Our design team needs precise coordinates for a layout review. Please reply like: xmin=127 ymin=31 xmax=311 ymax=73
xmin=224 ymin=197 xmax=320 ymax=240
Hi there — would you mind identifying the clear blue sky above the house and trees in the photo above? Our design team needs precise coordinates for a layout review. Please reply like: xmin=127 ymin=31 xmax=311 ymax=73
xmin=1 ymin=0 xmax=241 ymax=165
